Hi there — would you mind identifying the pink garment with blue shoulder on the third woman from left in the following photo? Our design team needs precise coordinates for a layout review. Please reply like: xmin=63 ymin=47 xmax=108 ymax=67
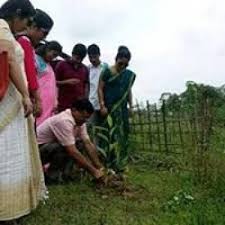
xmin=36 ymin=55 xmax=57 ymax=127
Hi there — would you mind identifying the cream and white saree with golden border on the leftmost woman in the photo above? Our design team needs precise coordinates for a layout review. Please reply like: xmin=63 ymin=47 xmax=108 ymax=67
xmin=0 ymin=19 xmax=46 ymax=221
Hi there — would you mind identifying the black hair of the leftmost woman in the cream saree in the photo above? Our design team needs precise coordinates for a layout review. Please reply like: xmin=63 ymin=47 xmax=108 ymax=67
xmin=0 ymin=0 xmax=35 ymax=20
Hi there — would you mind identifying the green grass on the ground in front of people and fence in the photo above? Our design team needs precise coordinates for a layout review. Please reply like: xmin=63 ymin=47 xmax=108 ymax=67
xmin=19 ymin=157 xmax=225 ymax=225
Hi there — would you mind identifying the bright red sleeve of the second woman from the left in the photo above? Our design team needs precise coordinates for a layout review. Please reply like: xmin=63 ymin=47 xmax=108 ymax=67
xmin=17 ymin=36 xmax=38 ymax=91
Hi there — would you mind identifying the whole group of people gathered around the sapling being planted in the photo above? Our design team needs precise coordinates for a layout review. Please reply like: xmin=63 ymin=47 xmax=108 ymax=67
xmin=0 ymin=0 xmax=135 ymax=223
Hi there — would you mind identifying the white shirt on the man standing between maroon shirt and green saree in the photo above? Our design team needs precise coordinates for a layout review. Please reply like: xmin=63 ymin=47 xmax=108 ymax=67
xmin=88 ymin=63 xmax=108 ymax=110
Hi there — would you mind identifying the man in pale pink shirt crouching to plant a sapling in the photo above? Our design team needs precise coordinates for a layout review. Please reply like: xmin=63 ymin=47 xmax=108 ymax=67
xmin=37 ymin=99 xmax=104 ymax=179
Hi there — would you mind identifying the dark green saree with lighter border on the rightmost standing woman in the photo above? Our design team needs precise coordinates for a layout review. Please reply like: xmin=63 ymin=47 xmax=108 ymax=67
xmin=100 ymin=68 xmax=136 ymax=170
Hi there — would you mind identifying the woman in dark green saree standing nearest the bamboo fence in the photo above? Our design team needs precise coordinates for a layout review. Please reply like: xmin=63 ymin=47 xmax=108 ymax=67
xmin=98 ymin=46 xmax=136 ymax=171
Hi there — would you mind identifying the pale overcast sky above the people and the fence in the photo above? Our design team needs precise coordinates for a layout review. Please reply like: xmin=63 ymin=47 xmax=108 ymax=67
xmin=0 ymin=0 xmax=225 ymax=102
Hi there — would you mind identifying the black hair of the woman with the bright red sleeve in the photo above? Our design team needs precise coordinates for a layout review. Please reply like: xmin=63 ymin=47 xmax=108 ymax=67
xmin=32 ymin=9 xmax=54 ymax=32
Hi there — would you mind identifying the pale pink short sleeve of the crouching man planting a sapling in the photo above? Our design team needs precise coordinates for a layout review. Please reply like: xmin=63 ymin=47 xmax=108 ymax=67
xmin=51 ymin=120 xmax=75 ymax=146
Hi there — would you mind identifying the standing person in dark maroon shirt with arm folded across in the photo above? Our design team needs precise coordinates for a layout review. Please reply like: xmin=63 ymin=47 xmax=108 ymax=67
xmin=56 ymin=44 xmax=89 ymax=112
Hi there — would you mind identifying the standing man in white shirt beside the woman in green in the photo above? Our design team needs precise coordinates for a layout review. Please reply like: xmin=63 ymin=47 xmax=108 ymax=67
xmin=88 ymin=44 xmax=108 ymax=126
